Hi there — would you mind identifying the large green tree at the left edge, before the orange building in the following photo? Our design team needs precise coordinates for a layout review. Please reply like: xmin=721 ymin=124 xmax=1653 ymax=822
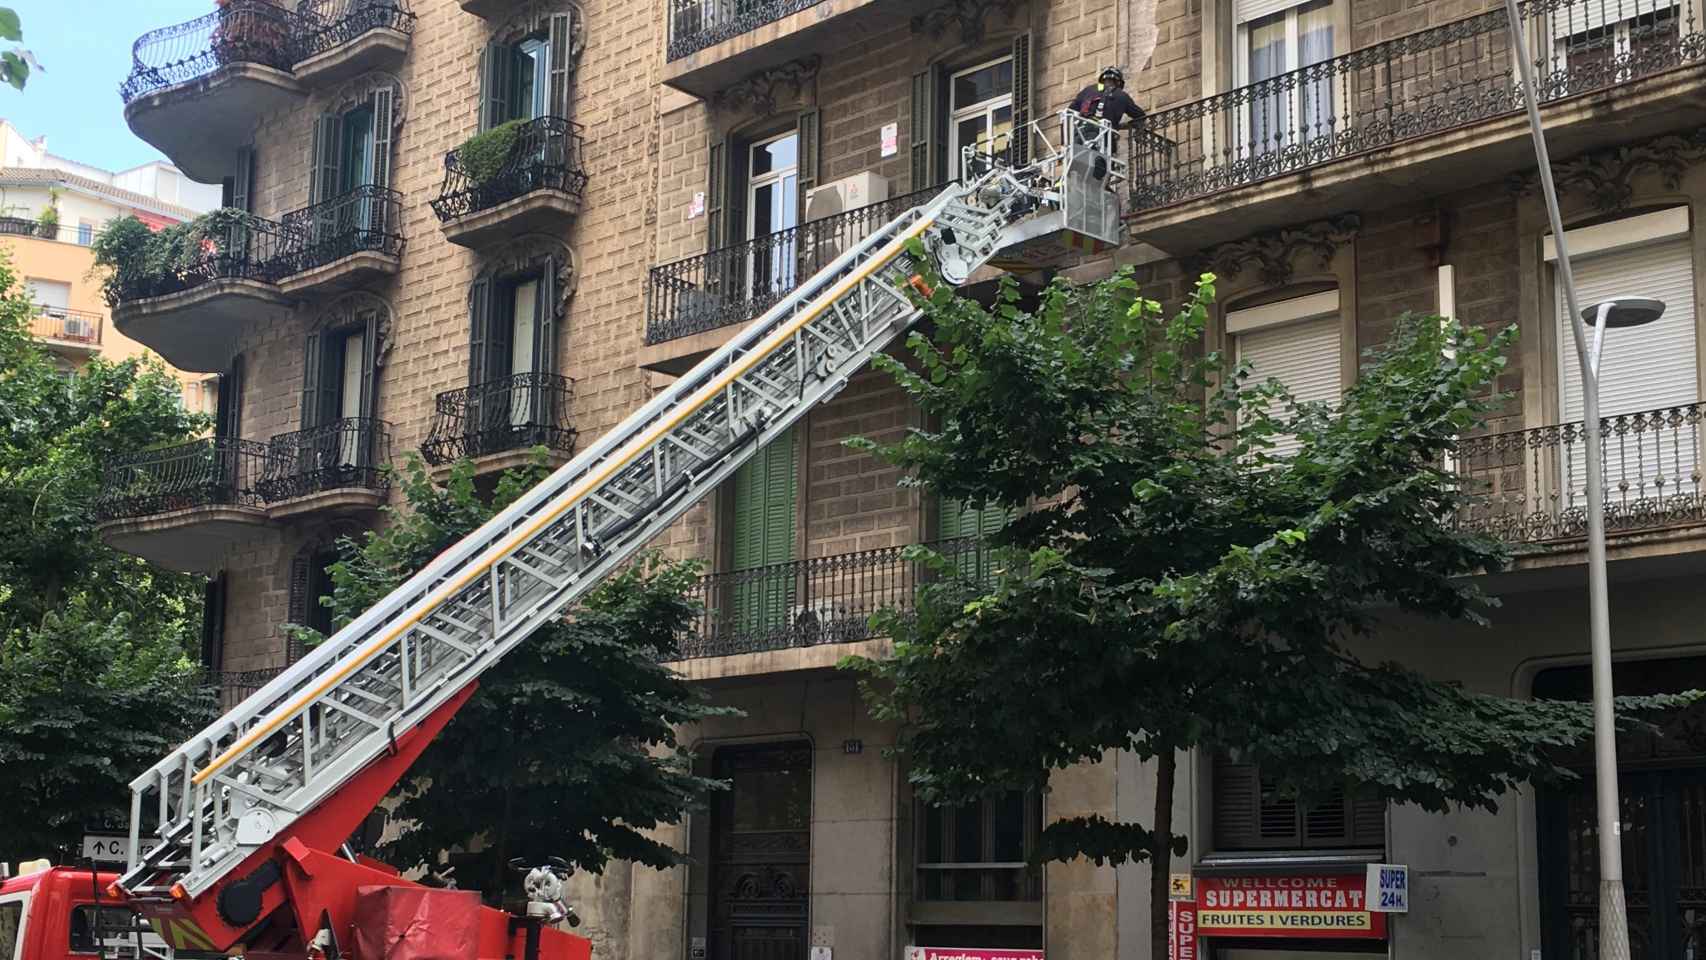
xmin=0 ymin=252 xmax=212 ymax=859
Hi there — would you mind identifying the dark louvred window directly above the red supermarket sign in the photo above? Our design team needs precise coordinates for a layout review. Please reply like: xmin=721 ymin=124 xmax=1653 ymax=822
xmin=1215 ymin=757 xmax=1385 ymax=853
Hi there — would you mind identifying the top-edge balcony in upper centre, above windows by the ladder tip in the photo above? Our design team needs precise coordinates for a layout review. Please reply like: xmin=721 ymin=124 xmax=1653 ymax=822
xmin=664 ymin=0 xmax=923 ymax=99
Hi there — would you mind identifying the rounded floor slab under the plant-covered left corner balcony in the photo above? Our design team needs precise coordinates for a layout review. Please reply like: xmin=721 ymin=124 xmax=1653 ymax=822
xmin=113 ymin=280 xmax=290 ymax=373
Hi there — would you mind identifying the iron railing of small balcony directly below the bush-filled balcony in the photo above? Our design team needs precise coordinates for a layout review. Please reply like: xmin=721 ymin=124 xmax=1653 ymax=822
xmin=421 ymin=373 xmax=578 ymax=466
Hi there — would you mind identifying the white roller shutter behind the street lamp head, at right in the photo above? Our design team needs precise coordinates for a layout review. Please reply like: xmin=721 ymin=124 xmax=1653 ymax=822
xmin=1556 ymin=235 xmax=1699 ymax=505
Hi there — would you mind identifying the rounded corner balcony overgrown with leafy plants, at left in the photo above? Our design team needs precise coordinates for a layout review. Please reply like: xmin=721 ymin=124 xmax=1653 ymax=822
xmin=113 ymin=217 xmax=290 ymax=373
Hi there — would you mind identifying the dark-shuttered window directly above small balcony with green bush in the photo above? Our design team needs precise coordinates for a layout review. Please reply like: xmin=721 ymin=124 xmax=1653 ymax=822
xmin=479 ymin=10 xmax=575 ymax=130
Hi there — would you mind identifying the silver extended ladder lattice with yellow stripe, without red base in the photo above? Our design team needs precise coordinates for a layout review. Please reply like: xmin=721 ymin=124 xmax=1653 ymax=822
xmin=119 ymin=114 xmax=1132 ymax=899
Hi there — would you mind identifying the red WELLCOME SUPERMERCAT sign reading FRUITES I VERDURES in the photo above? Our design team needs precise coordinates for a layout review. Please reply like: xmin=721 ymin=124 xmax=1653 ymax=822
xmin=1196 ymin=873 xmax=1387 ymax=940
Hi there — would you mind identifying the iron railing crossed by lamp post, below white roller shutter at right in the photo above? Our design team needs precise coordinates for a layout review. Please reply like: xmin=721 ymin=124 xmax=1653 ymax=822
xmin=1452 ymin=404 xmax=1706 ymax=544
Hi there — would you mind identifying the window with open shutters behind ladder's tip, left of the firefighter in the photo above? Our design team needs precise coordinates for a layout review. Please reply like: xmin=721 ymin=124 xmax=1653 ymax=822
xmin=908 ymin=34 xmax=1034 ymax=189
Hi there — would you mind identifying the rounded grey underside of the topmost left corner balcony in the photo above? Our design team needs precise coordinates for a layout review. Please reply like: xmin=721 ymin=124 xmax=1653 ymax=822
xmin=125 ymin=63 xmax=305 ymax=184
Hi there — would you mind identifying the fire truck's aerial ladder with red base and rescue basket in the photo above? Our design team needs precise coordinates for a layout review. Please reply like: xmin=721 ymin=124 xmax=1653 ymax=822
xmin=103 ymin=113 xmax=1124 ymax=960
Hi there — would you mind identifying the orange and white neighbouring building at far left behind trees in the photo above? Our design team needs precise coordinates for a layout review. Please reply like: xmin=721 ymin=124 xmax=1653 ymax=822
xmin=0 ymin=119 xmax=220 ymax=405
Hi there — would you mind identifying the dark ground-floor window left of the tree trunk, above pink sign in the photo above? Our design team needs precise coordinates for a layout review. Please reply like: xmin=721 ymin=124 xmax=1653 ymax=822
xmin=916 ymin=791 xmax=1042 ymax=902
